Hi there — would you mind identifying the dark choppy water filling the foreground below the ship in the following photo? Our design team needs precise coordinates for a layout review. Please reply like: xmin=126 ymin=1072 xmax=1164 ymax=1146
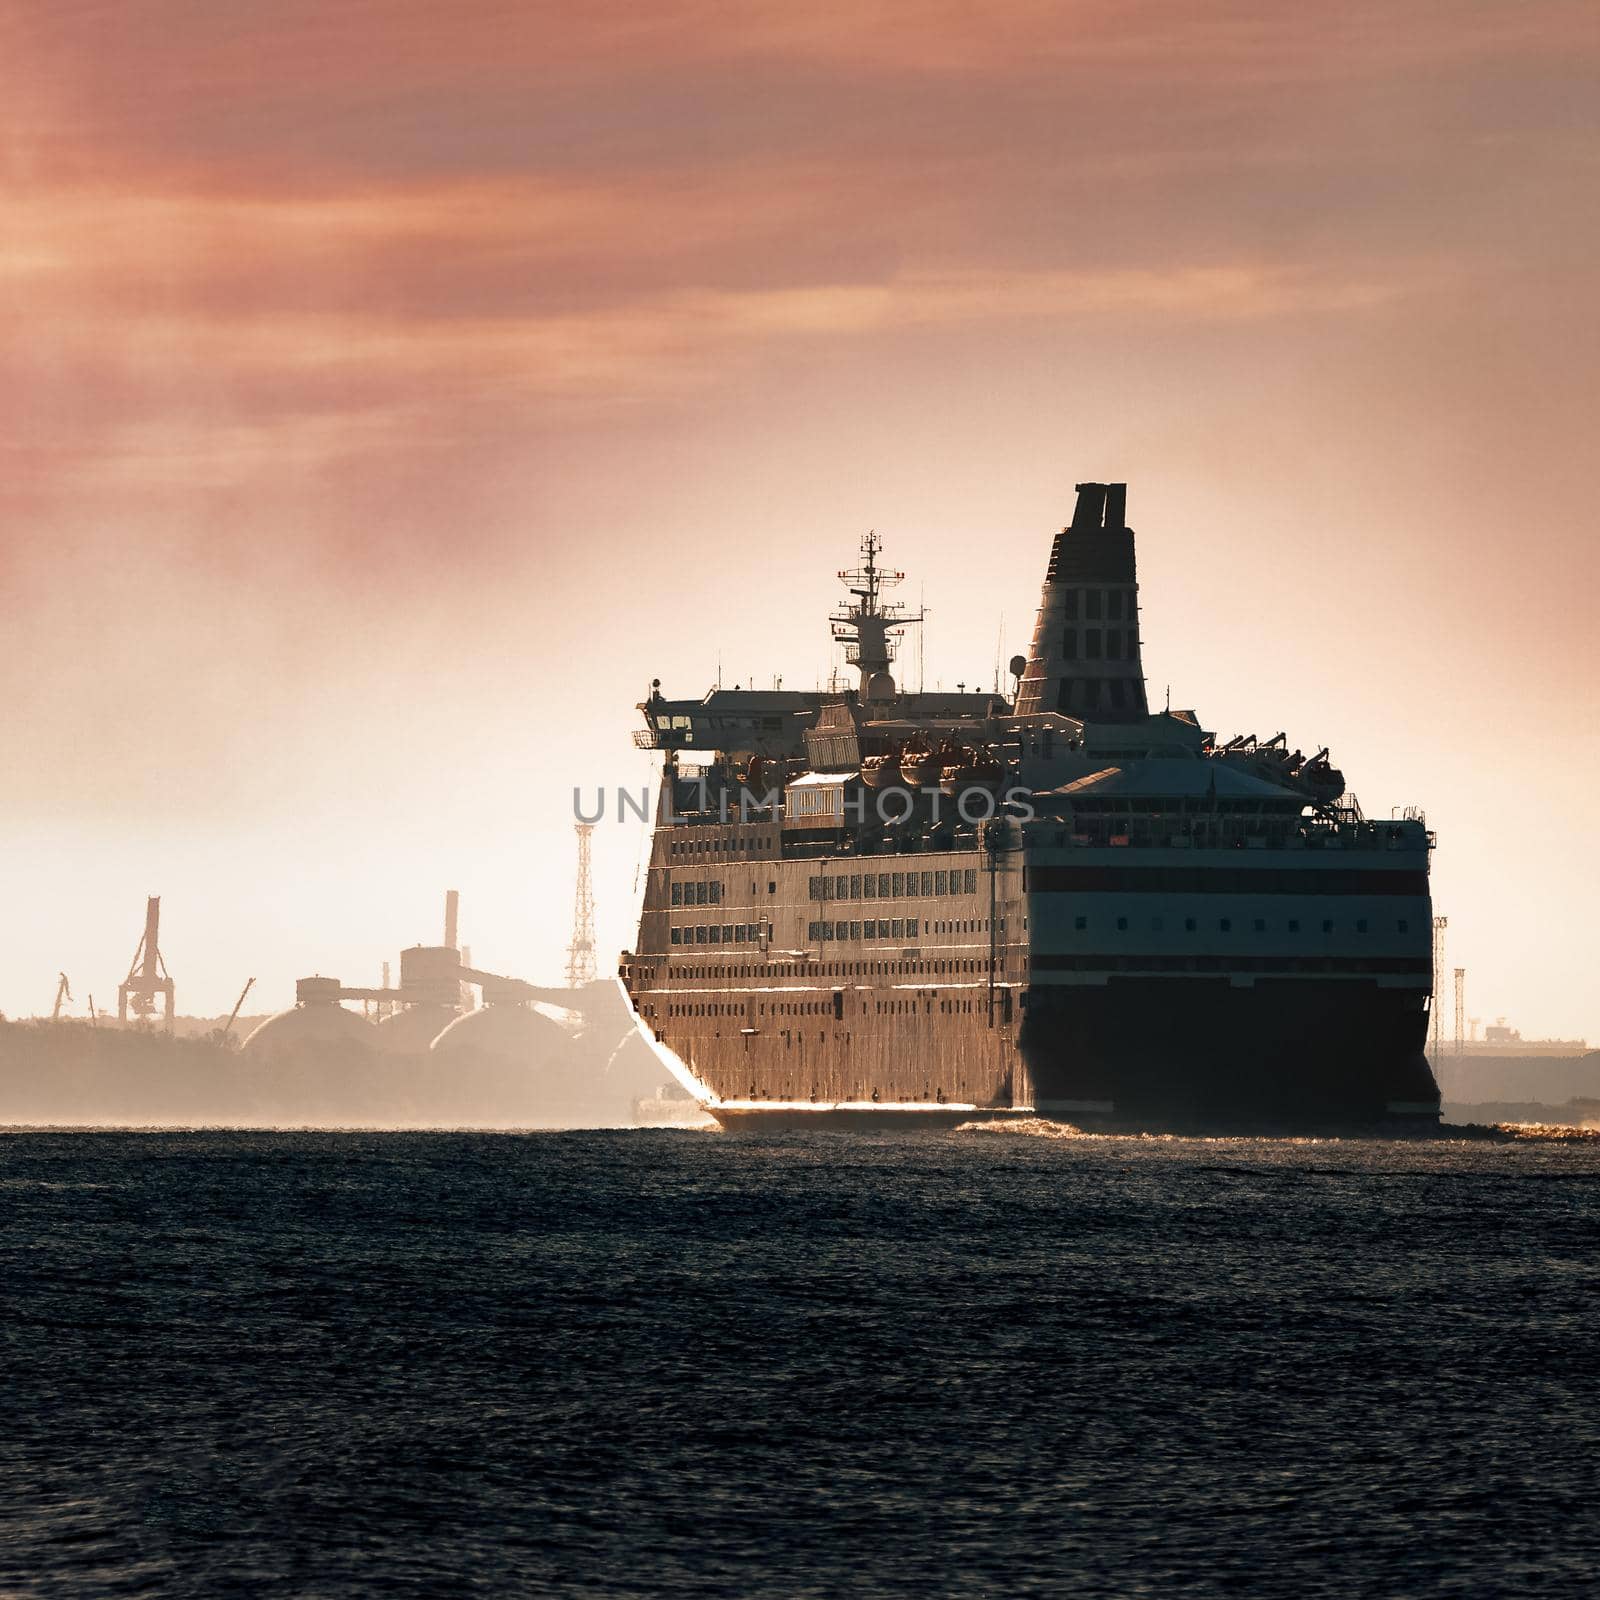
xmin=0 ymin=1131 xmax=1600 ymax=1597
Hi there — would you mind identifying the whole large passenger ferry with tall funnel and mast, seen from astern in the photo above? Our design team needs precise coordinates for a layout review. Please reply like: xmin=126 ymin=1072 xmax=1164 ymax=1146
xmin=619 ymin=483 xmax=1438 ymax=1130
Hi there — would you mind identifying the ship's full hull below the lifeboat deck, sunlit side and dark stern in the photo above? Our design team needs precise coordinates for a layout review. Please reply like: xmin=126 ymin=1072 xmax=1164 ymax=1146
xmin=621 ymin=777 xmax=1438 ymax=1133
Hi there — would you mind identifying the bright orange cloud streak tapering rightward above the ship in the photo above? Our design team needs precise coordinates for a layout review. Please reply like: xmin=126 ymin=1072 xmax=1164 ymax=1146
xmin=0 ymin=181 xmax=1429 ymax=496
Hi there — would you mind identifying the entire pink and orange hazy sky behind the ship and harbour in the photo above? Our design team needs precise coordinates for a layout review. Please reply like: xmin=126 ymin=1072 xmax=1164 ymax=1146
xmin=0 ymin=0 xmax=1600 ymax=1038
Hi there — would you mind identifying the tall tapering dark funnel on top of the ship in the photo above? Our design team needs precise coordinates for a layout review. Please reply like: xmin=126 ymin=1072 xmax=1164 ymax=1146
xmin=1016 ymin=483 xmax=1149 ymax=722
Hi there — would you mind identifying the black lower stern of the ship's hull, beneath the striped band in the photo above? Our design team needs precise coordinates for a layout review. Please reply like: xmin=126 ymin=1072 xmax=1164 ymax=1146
xmin=1021 ymin=978 xmax=1438 ymax=1133
